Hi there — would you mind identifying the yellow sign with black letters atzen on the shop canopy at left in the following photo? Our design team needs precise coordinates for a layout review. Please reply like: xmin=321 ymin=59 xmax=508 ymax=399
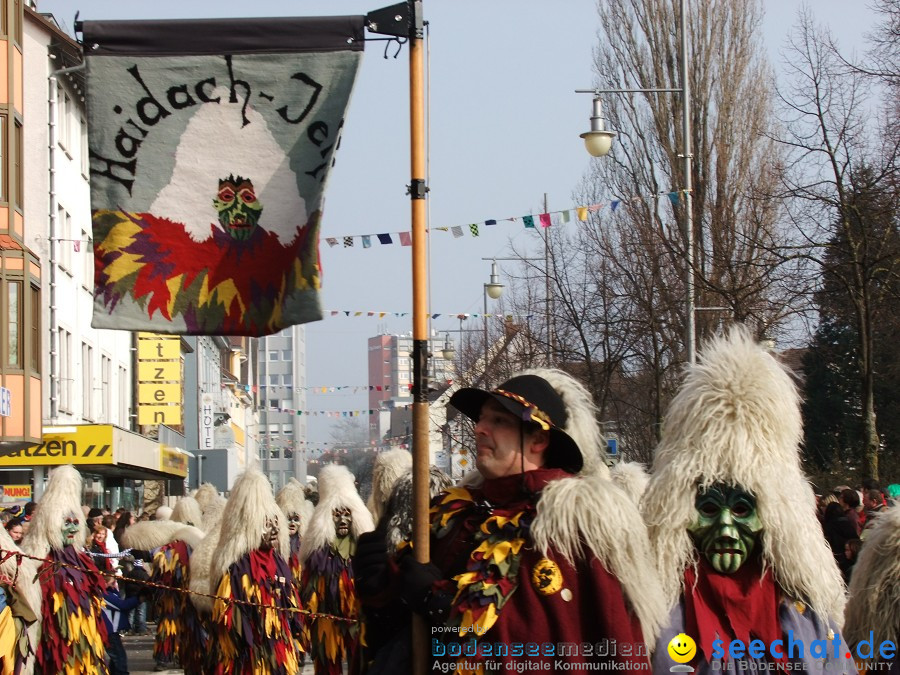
xmin=0 ymin=424 xmax=113 ymax=466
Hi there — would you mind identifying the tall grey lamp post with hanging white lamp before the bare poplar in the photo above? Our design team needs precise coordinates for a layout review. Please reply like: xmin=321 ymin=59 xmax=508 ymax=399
xmin=576 ymin=0 xmax=697 ymax=363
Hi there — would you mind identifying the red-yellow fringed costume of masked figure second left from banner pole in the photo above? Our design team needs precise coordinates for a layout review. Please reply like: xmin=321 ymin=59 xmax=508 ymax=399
xmin=213 ymin=549 xmax=303 ymax=675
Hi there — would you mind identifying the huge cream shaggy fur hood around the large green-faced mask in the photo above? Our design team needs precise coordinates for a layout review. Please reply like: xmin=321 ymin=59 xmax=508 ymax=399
xmin=642 ymin=327 xmax=844 ymax=625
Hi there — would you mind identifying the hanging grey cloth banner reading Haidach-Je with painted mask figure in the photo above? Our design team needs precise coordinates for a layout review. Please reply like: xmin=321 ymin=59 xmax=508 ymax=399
xmin=83 ymin=16 xmax=364 ymax=335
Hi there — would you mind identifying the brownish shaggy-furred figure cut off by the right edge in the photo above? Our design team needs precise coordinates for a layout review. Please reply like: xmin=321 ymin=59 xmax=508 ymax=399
xmin=842 ymin=506 xmax=900 ymax=675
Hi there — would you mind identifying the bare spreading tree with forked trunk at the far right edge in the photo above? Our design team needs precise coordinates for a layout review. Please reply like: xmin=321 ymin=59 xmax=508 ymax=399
xmin=780 ymin=11 xmax=900 ymax=479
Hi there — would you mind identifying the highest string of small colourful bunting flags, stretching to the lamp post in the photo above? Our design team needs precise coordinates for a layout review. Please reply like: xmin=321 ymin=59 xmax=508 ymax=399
xmin=325 ymin=190 xmax=685 ymax=248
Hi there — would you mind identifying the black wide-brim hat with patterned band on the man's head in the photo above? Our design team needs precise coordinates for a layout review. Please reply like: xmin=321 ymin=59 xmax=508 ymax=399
xmin=450 ymin=375 xmax=584 ymax=473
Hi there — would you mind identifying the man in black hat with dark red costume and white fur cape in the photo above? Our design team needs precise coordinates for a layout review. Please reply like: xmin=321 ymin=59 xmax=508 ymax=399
xmin=354 ymin=369 xmax=665 ymax=671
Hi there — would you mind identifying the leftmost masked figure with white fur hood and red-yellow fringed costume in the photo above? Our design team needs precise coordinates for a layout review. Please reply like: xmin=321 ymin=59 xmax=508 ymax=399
xmin=24 ymin=465 xmax=107 ymax=675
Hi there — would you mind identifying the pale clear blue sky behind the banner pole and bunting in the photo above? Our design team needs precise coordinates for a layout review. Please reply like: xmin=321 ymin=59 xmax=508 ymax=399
xmin=38 ymin=0 xmax=872 ymax=442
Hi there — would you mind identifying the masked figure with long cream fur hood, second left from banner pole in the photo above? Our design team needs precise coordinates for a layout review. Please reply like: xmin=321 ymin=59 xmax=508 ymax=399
xmin=209 ymin=469 xmax=303 ymax=675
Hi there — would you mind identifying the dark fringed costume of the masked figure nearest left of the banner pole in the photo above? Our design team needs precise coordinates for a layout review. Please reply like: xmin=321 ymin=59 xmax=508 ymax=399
xmin=301 ymin=537 xmax=361 ymax=675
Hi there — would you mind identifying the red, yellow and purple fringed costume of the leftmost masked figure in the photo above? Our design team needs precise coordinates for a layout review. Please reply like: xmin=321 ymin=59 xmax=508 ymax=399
xmin=35 ymin=546 xmax=107 ymax=675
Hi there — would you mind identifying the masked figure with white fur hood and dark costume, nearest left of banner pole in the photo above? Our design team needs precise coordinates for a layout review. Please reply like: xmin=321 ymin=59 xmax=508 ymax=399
xmin=300 ymin=464 xmax=375 ymax=675
